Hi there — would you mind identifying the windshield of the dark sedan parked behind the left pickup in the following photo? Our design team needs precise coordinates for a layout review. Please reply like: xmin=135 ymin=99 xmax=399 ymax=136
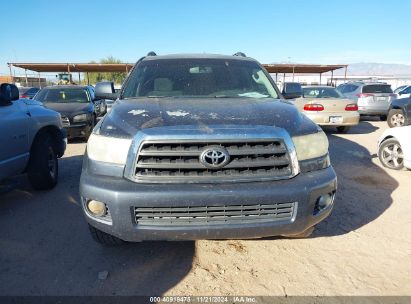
xmin=36 ymin=88 xmax=90 ymax=103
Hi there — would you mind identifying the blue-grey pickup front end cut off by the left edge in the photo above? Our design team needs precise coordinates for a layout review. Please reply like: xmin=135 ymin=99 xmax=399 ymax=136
xmin=0 ymin=84 xmax=66 ymax=190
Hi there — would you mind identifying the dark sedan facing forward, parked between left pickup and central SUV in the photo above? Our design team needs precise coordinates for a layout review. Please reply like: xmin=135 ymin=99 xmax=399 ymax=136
xmin=34 ymin=85 xmax=106 ymax=139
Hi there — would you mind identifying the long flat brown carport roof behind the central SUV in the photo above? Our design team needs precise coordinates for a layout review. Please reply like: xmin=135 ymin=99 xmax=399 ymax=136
xmin=9 ymin=63 xmax=347 ymax=74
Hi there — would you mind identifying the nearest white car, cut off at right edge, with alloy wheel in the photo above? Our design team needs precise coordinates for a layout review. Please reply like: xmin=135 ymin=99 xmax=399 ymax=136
xmin=378 ymin=126 xmax=411 ymax=170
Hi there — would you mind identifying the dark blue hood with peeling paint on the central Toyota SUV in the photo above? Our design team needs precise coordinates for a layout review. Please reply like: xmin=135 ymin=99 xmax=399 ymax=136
xmin=98 ymin=98 xmax=317 ymax=138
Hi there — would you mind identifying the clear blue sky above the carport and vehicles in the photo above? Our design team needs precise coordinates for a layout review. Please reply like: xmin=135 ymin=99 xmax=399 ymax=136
xmin=0 ymin=0 xmax=411 ymax=75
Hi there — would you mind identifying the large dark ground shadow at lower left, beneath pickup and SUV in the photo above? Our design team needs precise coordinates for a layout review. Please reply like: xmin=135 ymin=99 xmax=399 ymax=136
xmin=0 ymin=156 xmax=195 ymax=295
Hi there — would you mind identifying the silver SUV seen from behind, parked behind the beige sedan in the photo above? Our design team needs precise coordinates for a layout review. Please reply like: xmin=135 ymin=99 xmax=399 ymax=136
xmin=338 ymin=81 xmax=397 ymax=120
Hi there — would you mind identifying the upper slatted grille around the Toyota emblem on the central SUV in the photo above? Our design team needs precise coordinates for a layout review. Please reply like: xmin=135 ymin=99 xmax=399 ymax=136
xmin=134 ymin=139 xmax=293 ymax=182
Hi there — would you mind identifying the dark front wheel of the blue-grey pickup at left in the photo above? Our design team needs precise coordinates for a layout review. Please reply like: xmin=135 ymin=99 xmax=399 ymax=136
xmin=27 ymin=133 xmax=58 ymax=190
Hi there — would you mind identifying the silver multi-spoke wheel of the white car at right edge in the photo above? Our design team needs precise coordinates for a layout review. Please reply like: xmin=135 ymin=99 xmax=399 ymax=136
xmin=378 ymin=138 xmax=404 ymax=170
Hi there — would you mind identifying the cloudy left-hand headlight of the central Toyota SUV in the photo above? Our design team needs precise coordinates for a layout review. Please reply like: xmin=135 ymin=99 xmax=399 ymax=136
xmin=87 ymin=134 xmax=132 ymax=165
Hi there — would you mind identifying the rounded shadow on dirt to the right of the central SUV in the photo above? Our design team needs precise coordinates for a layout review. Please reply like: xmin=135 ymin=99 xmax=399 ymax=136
xmin=313 ymin=129 xmax=398 ymax=237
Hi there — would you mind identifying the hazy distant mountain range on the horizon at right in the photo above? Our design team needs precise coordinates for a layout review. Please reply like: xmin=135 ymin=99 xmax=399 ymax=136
xmin=335 ymin=62 xmax=411 ymax=77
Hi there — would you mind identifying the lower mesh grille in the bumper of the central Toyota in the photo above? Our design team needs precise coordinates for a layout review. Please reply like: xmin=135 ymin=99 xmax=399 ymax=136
xmin=134 ymin=203 xmax=297 ymax=226
